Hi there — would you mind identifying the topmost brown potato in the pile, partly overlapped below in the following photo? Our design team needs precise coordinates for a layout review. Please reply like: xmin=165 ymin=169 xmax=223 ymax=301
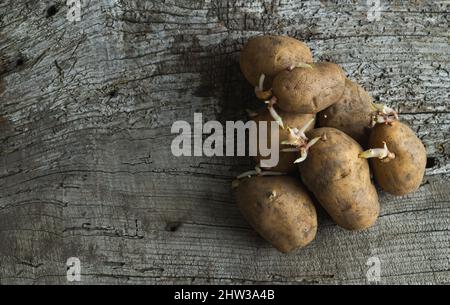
xmin=240 ymin=35 xmax=313 ymax=90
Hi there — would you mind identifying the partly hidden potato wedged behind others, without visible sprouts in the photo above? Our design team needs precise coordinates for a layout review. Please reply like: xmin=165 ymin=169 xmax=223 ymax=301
xmin=317 ymin=79 xmax=373 ymax=147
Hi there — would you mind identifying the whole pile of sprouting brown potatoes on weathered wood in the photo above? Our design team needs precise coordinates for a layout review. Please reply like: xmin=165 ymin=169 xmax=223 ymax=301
xmin=233 ymin=36 xmax=426 ymax=252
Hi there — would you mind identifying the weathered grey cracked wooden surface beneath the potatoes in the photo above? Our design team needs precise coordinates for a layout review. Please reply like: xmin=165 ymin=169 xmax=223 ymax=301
xmin=0 ymin=0 xmax=450 ymax=284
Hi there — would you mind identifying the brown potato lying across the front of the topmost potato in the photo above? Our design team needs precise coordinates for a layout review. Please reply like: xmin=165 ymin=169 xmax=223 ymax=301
xmin=272 ymin=62 xmax=345 ymax=113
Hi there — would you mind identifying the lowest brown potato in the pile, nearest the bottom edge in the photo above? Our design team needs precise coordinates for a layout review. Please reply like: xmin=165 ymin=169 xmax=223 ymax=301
xmin=236 ymin=176 xmax=317 ymax=252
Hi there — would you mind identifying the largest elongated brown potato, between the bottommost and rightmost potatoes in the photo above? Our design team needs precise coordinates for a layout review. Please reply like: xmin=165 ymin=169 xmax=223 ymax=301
xmin=299 ymin=127 xmax=380 ymax=230
